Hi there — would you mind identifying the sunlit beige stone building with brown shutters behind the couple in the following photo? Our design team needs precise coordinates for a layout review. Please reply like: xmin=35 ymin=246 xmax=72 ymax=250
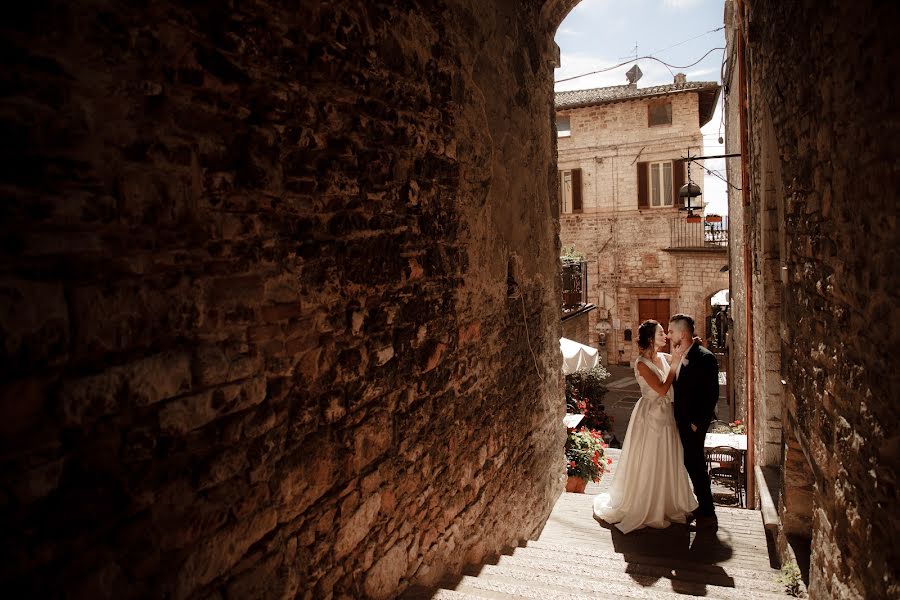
xmin=556 ymin=81 xmax=728 ymax=364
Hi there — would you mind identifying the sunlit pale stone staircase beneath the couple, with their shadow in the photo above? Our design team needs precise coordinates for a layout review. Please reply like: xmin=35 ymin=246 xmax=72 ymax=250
xmin=403 ymin=452 xmax=785 ymax=600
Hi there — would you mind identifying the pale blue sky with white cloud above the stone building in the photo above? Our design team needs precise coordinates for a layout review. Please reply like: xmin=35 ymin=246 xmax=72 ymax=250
xmin=556 ymin=0 xmax=728 ymax=214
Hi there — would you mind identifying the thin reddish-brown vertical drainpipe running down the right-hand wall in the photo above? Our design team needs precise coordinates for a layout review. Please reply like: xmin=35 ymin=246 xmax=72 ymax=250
xmin=735 ymin=0 xmax=756 ymax=507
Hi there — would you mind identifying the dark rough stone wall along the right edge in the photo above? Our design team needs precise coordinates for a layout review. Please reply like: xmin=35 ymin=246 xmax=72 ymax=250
xmin=729 ymin=0 xmax=900 ymax=598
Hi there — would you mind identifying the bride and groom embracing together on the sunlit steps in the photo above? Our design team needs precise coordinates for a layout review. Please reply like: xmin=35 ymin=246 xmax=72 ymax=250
xmin=594 ymin=314 xmax=719 ymax=533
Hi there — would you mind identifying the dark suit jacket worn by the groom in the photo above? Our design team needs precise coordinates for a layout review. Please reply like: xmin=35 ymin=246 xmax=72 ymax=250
xmin=673 ymin=344 xmax=719 ymax=429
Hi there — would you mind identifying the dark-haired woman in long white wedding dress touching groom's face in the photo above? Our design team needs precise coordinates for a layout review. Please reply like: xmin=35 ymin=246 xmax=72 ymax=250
xmin=594 ymin=320 xmax=697 ymax=533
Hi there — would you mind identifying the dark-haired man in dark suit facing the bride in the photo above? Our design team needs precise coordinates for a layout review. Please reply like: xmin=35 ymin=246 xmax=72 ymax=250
xmin=669 ymin=314 xmax=719 ymax=523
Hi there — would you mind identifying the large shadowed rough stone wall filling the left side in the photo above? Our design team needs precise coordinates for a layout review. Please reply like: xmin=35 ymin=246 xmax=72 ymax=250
xmin=0 ymin=0 xmax=565 ymax=598
